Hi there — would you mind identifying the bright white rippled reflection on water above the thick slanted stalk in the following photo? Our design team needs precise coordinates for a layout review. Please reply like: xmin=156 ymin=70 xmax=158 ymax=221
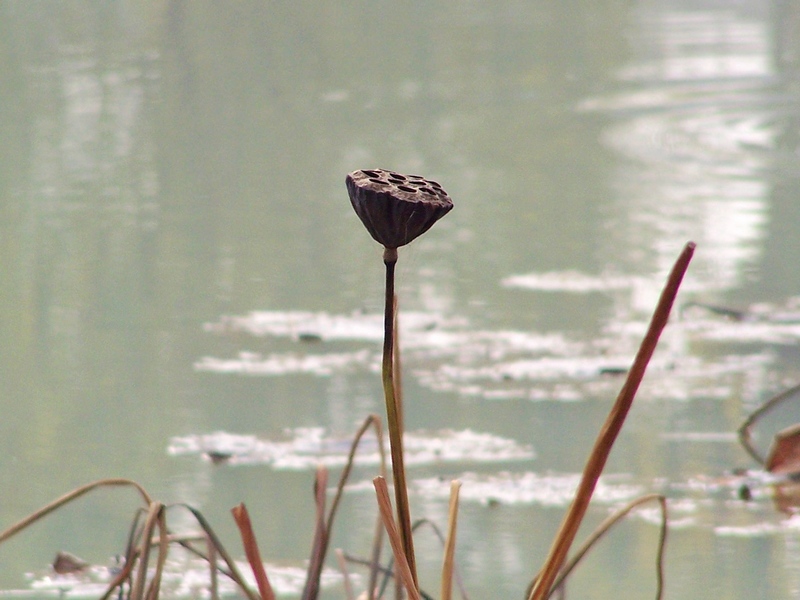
xmin=592 ymin=5 xmax=774 ymax=292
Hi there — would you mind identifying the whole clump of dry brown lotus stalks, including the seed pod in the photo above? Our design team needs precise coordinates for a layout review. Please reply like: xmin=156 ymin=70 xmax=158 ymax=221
xmin=0 ymin=169 xmax=694 ymax=600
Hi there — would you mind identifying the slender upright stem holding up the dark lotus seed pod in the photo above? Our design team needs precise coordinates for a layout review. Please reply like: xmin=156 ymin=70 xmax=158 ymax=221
xmin=382 ymin=248 xmax=417 ymax=584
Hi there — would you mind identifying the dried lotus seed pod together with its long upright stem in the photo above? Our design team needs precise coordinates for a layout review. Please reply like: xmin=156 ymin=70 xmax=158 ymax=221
xmin=346 ymin=169 xmax=453 ymax=587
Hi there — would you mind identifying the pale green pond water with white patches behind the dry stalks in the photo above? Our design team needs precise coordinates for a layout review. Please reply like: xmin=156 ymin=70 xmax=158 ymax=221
xmin=0 ymin=0 xmax=800 ymax=600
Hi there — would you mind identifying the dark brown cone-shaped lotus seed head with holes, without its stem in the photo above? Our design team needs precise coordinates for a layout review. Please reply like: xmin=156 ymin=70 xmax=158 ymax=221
xmin=345 ymin=169 xmax=453 ymax=248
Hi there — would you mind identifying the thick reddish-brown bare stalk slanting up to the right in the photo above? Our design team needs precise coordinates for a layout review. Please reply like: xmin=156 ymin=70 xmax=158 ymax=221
xmin=528 ymin=242 xmax=695 ymax=600
